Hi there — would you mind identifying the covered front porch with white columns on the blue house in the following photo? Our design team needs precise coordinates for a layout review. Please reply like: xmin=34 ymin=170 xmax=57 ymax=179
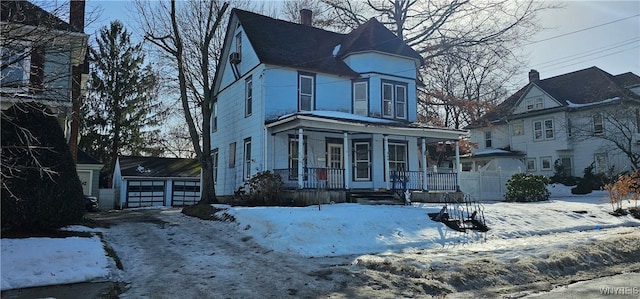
xmin=265 ymin=111 xmax=466 ymax=191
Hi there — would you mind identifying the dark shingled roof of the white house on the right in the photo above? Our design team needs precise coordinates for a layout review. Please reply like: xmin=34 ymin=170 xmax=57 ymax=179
xmin=467 ymin=66 xmax=640 ymax=128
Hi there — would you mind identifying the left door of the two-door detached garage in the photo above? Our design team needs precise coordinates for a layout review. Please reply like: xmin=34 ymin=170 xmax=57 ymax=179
xmin=126 ymin=181 xmax=165 ymax=208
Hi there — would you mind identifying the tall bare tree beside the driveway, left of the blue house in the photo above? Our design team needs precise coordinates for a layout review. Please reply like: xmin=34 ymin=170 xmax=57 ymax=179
xmin=137 ymin=0 xmax=229 ymax=203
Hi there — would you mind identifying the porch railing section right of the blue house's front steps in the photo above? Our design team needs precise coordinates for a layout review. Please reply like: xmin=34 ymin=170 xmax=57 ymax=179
xmin=391 ymin=171 xmax=458 ymax=191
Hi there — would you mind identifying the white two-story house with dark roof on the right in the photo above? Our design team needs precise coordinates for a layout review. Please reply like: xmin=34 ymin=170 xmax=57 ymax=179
xmin=463 ymin=67 xmax=640 ymax=180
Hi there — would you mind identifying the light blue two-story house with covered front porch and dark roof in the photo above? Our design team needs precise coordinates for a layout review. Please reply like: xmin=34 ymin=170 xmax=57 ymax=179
xmin=211 ymin=9 xmax=468 ymax=199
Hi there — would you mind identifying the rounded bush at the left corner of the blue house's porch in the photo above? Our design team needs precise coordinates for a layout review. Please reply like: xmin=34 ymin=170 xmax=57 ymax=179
xmin=234 ymin=170 xmax=290 ymax=206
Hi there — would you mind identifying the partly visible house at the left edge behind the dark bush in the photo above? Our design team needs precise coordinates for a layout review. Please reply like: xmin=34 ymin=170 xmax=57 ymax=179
xmin=0 ymin=1 xmax=88 ymax=139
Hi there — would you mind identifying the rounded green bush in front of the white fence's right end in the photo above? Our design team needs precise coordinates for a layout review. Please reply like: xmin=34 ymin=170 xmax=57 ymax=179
xmin=505 ymin=173 xmax=551 ymax=202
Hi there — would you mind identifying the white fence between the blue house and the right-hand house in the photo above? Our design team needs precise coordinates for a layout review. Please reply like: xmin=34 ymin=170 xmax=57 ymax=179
xmin=460 ymin=170 xmax=520 ymax=201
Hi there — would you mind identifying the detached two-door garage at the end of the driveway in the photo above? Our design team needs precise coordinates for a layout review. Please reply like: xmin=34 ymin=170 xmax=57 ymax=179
xmin=113 ymin=156 xmax=200 ymax=209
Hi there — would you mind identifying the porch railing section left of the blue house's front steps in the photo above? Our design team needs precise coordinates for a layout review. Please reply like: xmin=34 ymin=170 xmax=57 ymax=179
xmin=273 ymin=167 xmax=344 ymax=189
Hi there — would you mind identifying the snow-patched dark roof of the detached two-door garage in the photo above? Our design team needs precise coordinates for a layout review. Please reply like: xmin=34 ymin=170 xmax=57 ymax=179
xmin=119 ymin=156 xmax=200 ymax=178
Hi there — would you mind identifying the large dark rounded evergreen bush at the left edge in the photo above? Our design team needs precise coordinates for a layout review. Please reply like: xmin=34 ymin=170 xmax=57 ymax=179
xmin=1 ymin=103 xmax=85 ymax=231
